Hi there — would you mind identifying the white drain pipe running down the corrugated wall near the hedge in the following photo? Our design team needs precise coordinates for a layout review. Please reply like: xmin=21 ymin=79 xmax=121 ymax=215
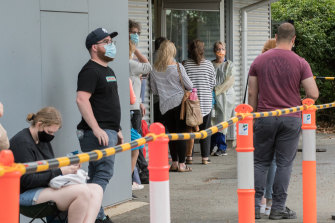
xmin=241 ymin=0 xmax=271 ymax=103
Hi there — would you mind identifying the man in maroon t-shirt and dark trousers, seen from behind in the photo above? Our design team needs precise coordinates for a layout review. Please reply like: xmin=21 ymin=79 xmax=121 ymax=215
xmin=248 ymin=23 xmax=319 ymax=220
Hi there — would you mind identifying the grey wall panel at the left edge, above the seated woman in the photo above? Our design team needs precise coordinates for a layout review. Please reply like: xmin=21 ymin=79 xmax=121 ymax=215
xmin=0 ymin=0 xmax=41 ymax=137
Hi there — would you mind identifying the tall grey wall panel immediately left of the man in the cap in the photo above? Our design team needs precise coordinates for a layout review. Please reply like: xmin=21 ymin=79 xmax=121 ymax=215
xmin=41 ymin=12 xmax=89 ymax=156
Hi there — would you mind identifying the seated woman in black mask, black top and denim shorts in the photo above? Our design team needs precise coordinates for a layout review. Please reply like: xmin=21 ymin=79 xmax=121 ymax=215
xmin=10 ymin=107 xmax=103 ymax=223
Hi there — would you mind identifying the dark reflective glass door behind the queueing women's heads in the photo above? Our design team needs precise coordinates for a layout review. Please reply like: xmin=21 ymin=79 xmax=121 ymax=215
xmin=165 ymin=9 xmax=220 ymax=62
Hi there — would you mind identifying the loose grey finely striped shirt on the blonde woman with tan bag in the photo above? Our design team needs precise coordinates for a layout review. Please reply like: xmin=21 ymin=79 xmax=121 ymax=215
xmin=150 ymin=64 xmax=193 ymax=114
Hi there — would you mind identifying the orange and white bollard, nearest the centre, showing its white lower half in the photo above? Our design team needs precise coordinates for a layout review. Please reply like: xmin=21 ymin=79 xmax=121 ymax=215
xmin=148 ymin=123 xmax=171 ymax=223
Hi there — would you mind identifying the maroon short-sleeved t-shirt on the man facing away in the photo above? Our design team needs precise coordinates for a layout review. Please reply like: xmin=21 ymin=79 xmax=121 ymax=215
xmin=249 ymin=49 xmax=313 ymax=117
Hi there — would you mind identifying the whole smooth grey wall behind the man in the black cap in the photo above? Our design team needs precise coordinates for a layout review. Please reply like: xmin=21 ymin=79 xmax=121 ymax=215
xmin=0 ymin=0 xmax=131 ymax=222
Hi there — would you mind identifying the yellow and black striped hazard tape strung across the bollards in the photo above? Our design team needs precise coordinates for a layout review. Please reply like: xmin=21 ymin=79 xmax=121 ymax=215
xmin=0 ymin=102 xmax=335 ymax=176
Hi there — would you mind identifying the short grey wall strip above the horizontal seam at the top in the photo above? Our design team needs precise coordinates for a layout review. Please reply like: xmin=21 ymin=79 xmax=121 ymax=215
xmin=40 ymin=0 xmax=88 ymax=13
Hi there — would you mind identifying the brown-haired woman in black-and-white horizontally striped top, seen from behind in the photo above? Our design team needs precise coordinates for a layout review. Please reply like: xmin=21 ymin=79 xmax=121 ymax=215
xmin=184 ymin=40 xmax=216 ymax=165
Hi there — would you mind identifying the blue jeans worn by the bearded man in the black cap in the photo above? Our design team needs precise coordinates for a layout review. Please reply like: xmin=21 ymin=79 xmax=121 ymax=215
xmin=77 ymin=129 xmax=118 ymax=219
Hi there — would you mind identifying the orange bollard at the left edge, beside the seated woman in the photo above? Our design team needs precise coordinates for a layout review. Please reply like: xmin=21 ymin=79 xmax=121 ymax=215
xmin=0 ymin=150 xmax=21 ymax=223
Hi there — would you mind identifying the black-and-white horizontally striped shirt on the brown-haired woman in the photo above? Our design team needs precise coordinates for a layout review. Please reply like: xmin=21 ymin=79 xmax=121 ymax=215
xmin=184 ymin=59 xmax=216 ymax=116
